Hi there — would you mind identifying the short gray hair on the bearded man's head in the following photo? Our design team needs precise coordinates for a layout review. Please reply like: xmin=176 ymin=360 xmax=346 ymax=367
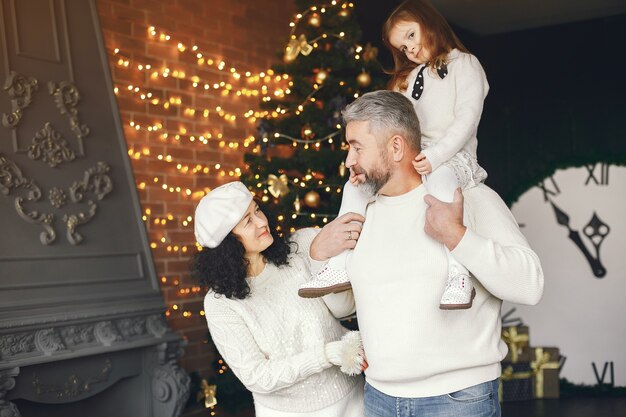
xmin=341 ymin=90 xmax=422 ymax=152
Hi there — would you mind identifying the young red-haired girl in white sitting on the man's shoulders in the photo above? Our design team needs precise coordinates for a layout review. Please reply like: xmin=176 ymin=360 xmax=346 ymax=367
xmin=298 ymin=0 xmax=489 ymax=310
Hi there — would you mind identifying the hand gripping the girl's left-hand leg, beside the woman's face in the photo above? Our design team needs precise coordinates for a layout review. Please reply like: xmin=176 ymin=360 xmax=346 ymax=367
xmin=310 ymin=213 xmax=365 ymax=261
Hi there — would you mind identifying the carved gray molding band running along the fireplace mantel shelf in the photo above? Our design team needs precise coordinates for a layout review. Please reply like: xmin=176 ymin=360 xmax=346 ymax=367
xmin=0 ymin=313 xmax=180 ymax=370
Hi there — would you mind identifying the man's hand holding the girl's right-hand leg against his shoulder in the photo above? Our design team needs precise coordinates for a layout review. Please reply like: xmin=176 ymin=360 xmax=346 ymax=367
xmin=424 ymin=188 xmax=466 ymax=250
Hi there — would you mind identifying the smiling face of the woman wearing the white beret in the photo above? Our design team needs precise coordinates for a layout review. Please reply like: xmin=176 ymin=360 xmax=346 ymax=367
xmin=233 ymin=200 xmax=274 ymax=254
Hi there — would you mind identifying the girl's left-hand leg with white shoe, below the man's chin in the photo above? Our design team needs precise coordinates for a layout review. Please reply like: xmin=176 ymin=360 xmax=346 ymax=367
xmin=298 ymin=181 xmax=370 ymax=298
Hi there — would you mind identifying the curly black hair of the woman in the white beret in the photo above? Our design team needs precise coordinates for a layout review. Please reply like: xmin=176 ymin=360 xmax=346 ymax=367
xmin=191 ymin=202 xmax=291 ymax=300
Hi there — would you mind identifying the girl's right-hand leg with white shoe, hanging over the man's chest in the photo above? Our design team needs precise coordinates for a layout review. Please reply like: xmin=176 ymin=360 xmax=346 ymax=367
xmin=424 ymin=165 xmax=475 ymax=310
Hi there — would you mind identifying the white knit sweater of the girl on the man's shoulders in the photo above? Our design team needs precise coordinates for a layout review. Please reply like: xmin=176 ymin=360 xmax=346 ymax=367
xmin=403 ymin=49 xmax=489 ymax=171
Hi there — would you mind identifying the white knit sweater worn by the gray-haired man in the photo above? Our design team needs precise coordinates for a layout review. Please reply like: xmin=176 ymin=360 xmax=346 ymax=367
xmin=325 ymin=184 xmax=543 ymax=398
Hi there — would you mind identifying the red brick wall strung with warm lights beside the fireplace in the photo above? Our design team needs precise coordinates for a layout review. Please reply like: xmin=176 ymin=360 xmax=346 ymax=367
xmin=98 ymin=0 xmax=295 ymax=375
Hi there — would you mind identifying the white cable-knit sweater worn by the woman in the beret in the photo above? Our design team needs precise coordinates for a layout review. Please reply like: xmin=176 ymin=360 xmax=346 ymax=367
xmin=204 ymin=229 xmax=361 ymax=416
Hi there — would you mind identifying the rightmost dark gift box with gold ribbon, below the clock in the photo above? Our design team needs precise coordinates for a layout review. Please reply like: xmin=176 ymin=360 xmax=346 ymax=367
xmin=530 ymin=347 xmax=561 ymax=398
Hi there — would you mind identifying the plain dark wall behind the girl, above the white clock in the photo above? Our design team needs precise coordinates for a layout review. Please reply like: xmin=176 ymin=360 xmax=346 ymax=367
xmin=357 ymin=4 xmax=626 ymax=203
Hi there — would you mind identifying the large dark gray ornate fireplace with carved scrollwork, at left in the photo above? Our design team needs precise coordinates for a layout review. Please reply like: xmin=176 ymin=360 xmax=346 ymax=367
xmin=0 ymin=0 xmax=189 ymax=417
